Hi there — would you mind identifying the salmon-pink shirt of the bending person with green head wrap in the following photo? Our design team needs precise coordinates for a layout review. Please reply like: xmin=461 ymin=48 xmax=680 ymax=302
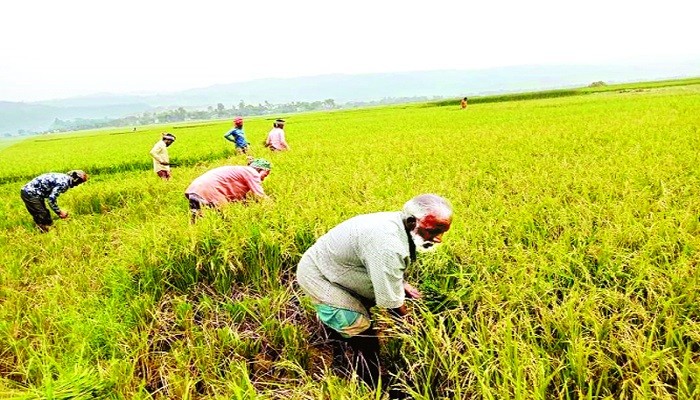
xmin=185 ymin=165 xmax=265 ymax=206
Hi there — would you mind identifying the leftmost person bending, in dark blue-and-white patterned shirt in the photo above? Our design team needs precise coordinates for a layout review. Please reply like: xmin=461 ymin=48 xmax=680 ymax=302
xmin=20 ymin=170 xmax=88 ymax=232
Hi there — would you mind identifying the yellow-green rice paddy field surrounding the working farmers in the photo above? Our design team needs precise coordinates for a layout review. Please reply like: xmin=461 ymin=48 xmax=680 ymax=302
xmin=0 ymin=80 xmax=700 ymax=399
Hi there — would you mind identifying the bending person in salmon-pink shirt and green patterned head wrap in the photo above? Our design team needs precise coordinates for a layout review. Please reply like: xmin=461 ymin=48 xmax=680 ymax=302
xmin=185 ymin=157 xmax=272 ymax=222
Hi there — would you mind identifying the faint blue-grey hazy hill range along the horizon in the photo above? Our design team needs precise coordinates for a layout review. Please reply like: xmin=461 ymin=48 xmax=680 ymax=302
xmin=0 ymin=58 xmax=700 ymax=136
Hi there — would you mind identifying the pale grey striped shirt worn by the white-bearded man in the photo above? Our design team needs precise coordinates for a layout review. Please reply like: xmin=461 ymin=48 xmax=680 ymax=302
xmin=297 ymin=212 xmax=410 ymax=314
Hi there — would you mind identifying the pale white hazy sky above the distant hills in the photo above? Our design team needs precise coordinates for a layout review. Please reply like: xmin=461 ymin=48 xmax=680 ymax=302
xmin=0 ymin=0 xmax=700 ymax=101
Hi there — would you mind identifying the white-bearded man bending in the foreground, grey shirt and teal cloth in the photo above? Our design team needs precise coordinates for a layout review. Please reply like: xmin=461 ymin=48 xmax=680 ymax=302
xmin=297 ymin=194 xmax=452 ymax=387
